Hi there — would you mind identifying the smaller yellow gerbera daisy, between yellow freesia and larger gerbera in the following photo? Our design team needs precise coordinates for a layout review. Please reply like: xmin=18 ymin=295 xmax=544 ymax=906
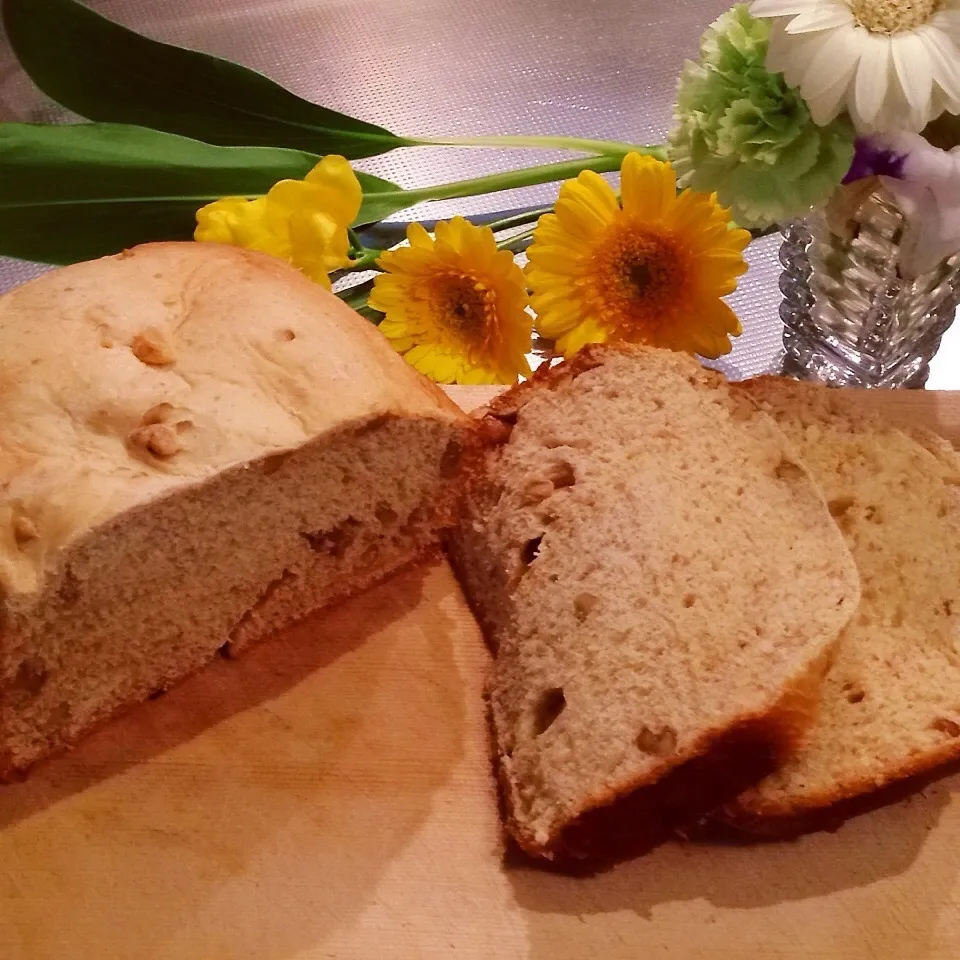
xmin=369 ymin=217 xmax=532 ymax=383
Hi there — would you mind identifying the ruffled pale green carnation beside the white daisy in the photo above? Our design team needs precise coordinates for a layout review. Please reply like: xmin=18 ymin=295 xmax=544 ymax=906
xmin=667 ymin=3 xmax=854 ymax=227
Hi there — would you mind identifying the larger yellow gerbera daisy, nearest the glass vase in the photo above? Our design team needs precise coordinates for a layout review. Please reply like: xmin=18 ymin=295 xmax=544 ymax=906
xmin=527 ymin=153 xmax=750 ymax=357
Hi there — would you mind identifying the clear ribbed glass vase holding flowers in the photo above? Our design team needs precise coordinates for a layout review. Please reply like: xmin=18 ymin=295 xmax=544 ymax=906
xmin=780 ymin=186 xmax=960 ymax=387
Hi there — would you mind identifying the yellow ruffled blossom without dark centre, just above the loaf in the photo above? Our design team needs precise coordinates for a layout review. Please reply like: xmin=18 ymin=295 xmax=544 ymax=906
xmin=194 ymin=155 xmax=363 ymax=290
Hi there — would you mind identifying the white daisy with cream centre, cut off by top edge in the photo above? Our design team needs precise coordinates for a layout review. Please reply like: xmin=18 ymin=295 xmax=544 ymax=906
xmin=750 ymin=0 xmax=960 ymax=131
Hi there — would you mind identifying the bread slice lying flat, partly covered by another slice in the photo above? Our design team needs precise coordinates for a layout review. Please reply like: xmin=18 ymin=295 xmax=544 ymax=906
xmin=724 ymin=378 xmax=960 ymax=832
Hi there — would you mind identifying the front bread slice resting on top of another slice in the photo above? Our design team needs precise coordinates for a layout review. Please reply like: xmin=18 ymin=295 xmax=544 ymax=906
xmin=451 ymin=346 xmax=859 ymax=857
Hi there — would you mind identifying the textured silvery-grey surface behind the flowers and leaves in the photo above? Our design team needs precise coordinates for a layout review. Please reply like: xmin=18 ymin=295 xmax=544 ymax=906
xmin=0 ymin=0 xmax=960 ymax=388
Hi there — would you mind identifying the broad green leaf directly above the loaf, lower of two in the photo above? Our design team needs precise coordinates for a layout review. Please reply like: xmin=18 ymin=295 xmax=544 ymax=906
xmin=0 ymin=123 xmax=399 ymax=264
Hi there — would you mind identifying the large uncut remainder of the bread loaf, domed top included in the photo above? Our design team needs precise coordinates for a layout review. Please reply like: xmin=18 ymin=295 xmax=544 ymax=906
xmin=0 ymin=243 xmax=467 ymax=776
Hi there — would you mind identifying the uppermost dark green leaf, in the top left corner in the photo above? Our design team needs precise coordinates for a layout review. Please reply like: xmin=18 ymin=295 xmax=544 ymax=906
xmin=3 ymin=0 xmax=414 ymax=160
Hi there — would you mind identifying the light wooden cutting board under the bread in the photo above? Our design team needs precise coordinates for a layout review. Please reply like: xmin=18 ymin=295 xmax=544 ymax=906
xmin=0 ymin=389 xmax=960 ymax=960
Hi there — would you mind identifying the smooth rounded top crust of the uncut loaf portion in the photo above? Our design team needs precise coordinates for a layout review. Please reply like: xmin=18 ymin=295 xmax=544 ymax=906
xmin=0 ymin=243 xmax=462 ymax=593
